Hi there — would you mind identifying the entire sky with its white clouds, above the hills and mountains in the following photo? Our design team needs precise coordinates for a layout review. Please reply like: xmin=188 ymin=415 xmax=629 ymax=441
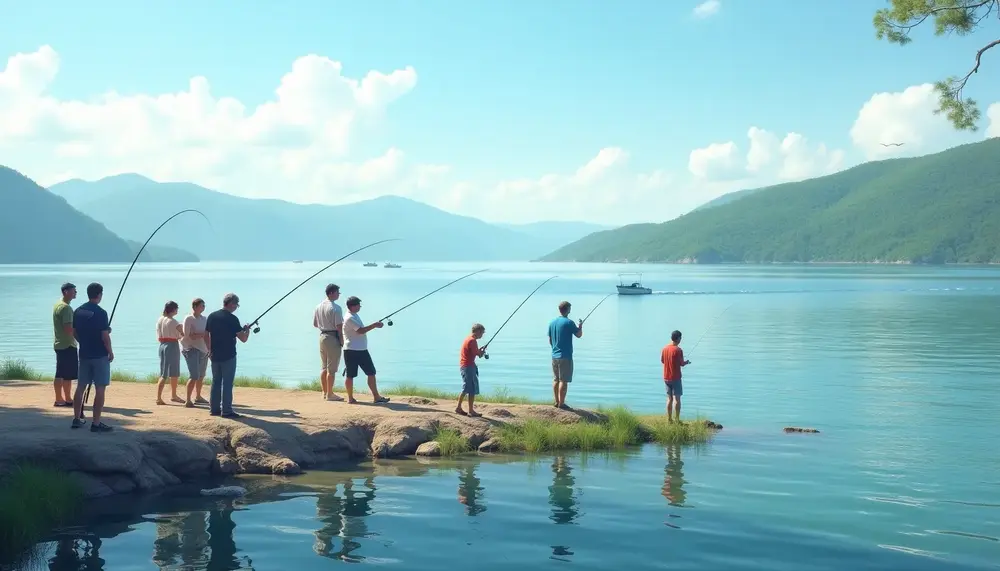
xmin=0 ymin=0 xmax=1000 ymax=225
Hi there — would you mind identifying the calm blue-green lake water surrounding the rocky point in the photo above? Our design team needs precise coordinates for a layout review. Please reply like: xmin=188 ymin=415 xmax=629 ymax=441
xmin=0 ymin=262 xmax=1000 ymax=571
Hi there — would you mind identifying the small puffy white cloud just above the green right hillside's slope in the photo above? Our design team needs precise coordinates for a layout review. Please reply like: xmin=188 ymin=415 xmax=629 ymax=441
xmin=688 ymin=127 xmax=844 ymax=184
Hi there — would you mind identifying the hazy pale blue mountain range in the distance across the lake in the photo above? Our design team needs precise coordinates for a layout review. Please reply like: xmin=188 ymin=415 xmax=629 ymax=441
xmin=49 ymin=174 xmax=592 ymax=261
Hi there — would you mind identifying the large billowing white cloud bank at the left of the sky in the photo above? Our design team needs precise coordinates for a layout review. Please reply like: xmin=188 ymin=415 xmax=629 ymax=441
xmin=0 ymin=46 xmax=418 ymax=202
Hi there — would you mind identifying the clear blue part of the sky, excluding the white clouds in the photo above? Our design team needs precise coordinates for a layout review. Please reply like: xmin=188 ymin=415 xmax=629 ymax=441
xmin=0 ymin=0 xmax=1000 ymax=223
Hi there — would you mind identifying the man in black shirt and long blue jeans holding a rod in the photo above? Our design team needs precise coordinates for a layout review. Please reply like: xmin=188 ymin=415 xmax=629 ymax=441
xmin=205 ymin=293 xmax=250 ymax=418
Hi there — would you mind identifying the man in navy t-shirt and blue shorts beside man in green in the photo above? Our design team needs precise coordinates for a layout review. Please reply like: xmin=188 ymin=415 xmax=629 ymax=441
xmin=73 ymin=282 xmax=115 ymax=432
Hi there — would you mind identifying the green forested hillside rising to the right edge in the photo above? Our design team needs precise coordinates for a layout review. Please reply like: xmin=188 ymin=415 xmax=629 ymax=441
xmin=542 ymin=138 xmax=1000 ymax=263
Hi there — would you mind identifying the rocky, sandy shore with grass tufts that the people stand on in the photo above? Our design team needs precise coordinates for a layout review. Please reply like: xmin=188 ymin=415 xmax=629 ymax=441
xmin=0 ymin=380 xmax=722 ymax=499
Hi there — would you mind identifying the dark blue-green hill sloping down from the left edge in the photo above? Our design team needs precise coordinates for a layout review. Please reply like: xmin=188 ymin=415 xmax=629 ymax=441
xmin=0 ymin=166 xmax=197 ymax=264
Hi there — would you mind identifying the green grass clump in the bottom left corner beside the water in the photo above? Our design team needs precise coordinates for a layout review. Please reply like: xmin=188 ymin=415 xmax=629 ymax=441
xmin=0 ymin=465 xmax=83 ymax=559
